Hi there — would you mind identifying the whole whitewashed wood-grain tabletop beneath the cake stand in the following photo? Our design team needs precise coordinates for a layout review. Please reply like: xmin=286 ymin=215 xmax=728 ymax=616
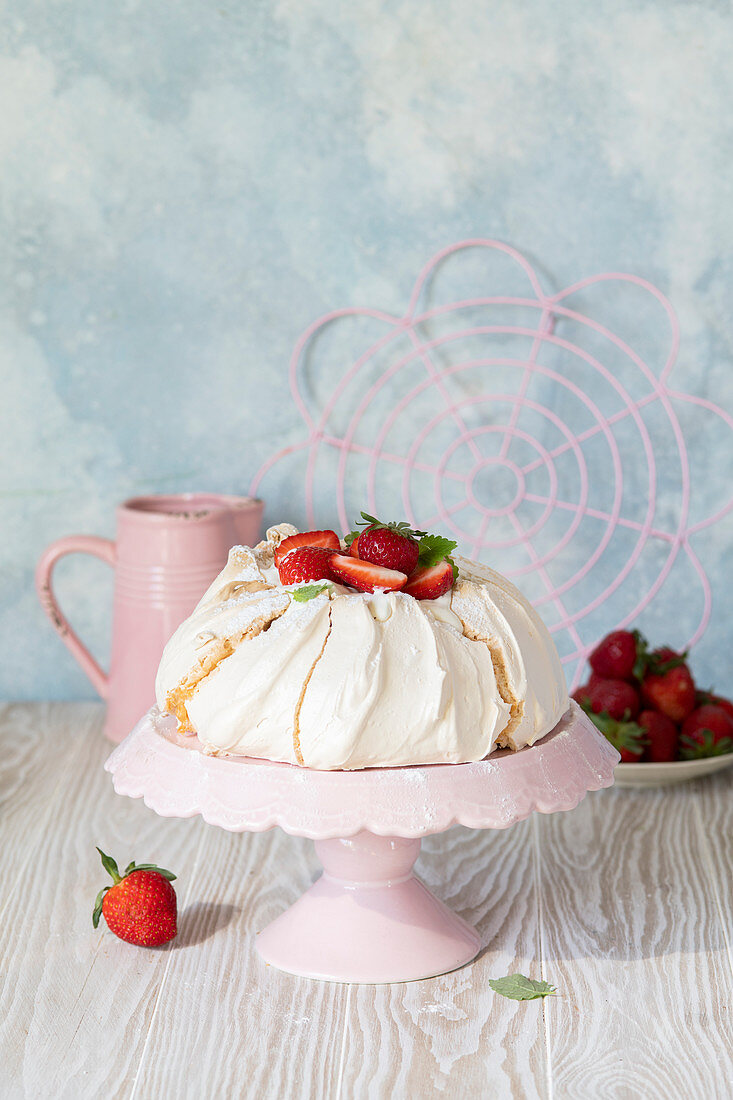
xmin=0 ymin=703 xmax=733 ymax=1100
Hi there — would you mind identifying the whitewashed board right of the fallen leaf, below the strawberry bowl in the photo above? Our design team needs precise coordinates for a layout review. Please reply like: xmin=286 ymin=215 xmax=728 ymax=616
xmin=530 ymin=784 xmax=733 ymax=1100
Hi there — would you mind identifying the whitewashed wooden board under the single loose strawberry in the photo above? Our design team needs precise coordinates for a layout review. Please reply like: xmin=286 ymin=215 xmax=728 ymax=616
xmin=0 ymin=704 xmax=200 ymax=1100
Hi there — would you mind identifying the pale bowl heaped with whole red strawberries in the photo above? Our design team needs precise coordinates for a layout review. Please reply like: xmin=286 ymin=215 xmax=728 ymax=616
xmin=572 ymin=630 xmax=733 ymax=787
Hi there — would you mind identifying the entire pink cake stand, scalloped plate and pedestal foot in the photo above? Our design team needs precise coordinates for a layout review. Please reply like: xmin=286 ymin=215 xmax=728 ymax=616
xmin=105 ymin=703 xmax=619 ymax=982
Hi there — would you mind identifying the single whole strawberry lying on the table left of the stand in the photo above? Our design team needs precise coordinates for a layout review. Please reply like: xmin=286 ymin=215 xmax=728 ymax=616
xmin=91 ymin=848 xmax=178 ymax=947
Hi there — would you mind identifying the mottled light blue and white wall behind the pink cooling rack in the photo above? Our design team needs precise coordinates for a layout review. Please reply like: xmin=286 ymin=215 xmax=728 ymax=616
xmin=0 ymin=0 xmax=733 ymax=697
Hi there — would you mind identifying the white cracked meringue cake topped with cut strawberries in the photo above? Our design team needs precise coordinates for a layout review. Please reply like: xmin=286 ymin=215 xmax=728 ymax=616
xmin=155 ymin=517 xmax=568 ymax=770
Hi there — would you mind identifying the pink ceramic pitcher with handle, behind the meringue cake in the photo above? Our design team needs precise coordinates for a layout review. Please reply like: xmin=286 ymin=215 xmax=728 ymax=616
xmin=35 ymin=493 xmax=263 ymax=741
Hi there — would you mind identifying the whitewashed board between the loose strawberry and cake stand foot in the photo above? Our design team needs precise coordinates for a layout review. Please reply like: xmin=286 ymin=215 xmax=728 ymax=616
xmin=133 ymin=827 xmax=348 ymax=1100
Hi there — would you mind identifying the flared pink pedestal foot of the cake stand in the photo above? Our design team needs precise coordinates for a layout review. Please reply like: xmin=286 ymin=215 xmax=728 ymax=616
xmin=256 ymin=831 xmax=481 ymax=983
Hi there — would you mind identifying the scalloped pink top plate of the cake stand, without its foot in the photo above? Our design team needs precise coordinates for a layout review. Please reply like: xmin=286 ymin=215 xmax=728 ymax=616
xmin=105 ymin=701 xmax=619 ymax=840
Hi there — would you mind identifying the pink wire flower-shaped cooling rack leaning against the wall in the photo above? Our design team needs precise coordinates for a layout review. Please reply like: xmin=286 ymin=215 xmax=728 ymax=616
xmin=251 ymin=240 xmax=733 ymax=685
